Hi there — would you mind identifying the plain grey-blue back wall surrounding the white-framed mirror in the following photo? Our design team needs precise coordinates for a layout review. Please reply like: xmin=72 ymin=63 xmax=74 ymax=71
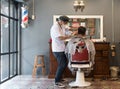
xmin=22 ymin=0 xmax=120 ymax=75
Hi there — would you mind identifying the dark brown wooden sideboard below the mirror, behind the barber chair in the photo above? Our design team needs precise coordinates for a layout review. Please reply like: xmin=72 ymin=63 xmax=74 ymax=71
xmin=48 ymin=42 xmax=110 ymax=78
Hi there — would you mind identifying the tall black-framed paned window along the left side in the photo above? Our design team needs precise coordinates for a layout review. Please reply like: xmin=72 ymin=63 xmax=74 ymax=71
xmin=0 ymin=0 xmax=20 ymax=83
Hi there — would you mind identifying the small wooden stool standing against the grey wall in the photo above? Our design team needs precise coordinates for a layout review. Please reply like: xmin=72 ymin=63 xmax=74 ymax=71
xmin=32 ymin=55 xmax=45 ymax=77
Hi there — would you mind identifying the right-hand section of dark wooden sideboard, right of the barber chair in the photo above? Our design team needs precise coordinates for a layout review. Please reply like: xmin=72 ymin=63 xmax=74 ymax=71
xmin=93 ymin=42 xmax=110 ymax=78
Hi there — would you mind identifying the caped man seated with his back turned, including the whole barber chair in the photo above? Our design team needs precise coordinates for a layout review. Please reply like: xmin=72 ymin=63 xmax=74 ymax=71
xmin=65 ymin=26 xmax=95 ymax=87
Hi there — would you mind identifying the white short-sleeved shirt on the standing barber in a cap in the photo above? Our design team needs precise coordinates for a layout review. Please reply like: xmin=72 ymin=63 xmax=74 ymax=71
xmin=50 ymin=23 xmax=65 ymax=52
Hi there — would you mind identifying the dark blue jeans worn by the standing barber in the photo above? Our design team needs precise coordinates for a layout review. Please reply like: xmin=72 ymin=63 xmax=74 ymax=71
xmin=53 ymin=52 xmax=68 ymax=83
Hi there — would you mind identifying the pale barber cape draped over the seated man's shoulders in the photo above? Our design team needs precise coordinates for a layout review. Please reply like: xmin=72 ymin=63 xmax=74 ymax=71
xmin=65 ymin=37 xmax=95 ymax=72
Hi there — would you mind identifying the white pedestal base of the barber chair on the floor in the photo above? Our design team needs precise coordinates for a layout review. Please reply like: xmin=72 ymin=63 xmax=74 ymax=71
xmin=69 ymin=70 xmax=91 ymax=87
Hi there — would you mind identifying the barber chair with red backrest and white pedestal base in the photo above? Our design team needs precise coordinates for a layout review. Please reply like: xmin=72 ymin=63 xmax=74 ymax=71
xmin=69 ymin=43 xmax=92 ymax=87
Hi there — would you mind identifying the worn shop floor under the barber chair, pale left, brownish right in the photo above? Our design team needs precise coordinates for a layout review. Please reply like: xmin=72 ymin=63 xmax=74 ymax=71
xmin=0 ymin=75 xmax=120 ymax=89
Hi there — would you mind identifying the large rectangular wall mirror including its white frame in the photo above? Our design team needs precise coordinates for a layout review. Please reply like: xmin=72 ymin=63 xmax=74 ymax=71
xmin=53 ymin=15 xmax=103 ymax=41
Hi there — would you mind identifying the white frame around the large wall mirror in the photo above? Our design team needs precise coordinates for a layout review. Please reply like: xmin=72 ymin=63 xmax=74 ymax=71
xmin=53 ymin=15 xmax=103 ymax=42
